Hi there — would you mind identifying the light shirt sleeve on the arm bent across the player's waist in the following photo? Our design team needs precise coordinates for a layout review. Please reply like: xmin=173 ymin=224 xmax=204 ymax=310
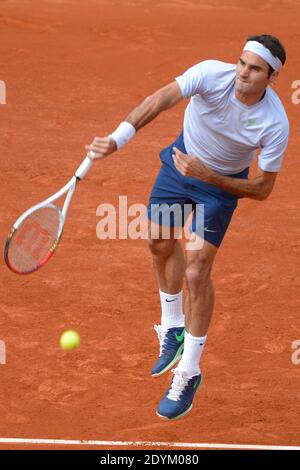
xmin=258 ymin=121 xmax=289 ymax=172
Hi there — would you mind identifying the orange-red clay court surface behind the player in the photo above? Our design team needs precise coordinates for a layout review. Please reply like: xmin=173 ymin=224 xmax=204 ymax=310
xmin=0 ymin=0 xmax=300 ymax=449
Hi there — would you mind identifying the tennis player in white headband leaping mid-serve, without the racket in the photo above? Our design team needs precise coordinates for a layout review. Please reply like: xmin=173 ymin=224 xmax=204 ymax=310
xmin=86 ymin=35 xmax=289 ymax=420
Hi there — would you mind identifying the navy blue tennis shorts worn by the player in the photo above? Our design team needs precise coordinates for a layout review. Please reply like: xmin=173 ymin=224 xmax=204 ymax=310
xmin=148 ymin=133 xmax=249 ymax=247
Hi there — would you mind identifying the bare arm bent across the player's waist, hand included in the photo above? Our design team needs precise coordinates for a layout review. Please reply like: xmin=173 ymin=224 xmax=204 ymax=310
xmin=173 ymin=147 xmax=277 ymax=201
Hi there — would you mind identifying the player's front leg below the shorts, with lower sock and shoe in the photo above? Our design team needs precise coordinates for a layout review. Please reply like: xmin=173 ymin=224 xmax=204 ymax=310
xmin=157 ymin=234 xmax=218 ymax=419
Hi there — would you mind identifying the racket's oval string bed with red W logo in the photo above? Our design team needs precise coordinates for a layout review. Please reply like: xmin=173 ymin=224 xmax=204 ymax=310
xmin=7 ymin=205 xmax=62 ymax=273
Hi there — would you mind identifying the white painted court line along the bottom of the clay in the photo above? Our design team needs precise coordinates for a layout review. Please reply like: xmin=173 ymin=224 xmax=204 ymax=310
xmin=0 ymin=438 xmax=300 ymax=450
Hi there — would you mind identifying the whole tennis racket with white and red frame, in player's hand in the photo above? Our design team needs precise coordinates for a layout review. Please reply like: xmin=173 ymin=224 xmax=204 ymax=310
xmin=4 ymin=152 xmax=93 ymax=274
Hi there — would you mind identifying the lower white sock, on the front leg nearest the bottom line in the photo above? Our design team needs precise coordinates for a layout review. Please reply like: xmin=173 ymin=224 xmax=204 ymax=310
xmin=177 ymin=331 xmax=207 ymax=377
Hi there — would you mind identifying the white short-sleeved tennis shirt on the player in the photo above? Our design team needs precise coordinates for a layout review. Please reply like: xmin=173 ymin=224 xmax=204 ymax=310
xmin=176 ymin=60 xmax=289 ymax=175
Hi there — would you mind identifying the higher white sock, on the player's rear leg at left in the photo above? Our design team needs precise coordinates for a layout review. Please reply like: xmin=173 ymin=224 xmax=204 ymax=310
xmin=159 ymin=290 xmax=184 ymax=329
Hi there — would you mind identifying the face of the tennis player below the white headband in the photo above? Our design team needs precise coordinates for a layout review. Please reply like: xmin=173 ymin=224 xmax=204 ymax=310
xmin=235 ymin=51 xmax=273 ymax=95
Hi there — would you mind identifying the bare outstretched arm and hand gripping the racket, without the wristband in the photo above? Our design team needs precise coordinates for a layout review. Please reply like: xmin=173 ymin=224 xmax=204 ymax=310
xmin=86 ymin=81 xmax=183 ymax=160
